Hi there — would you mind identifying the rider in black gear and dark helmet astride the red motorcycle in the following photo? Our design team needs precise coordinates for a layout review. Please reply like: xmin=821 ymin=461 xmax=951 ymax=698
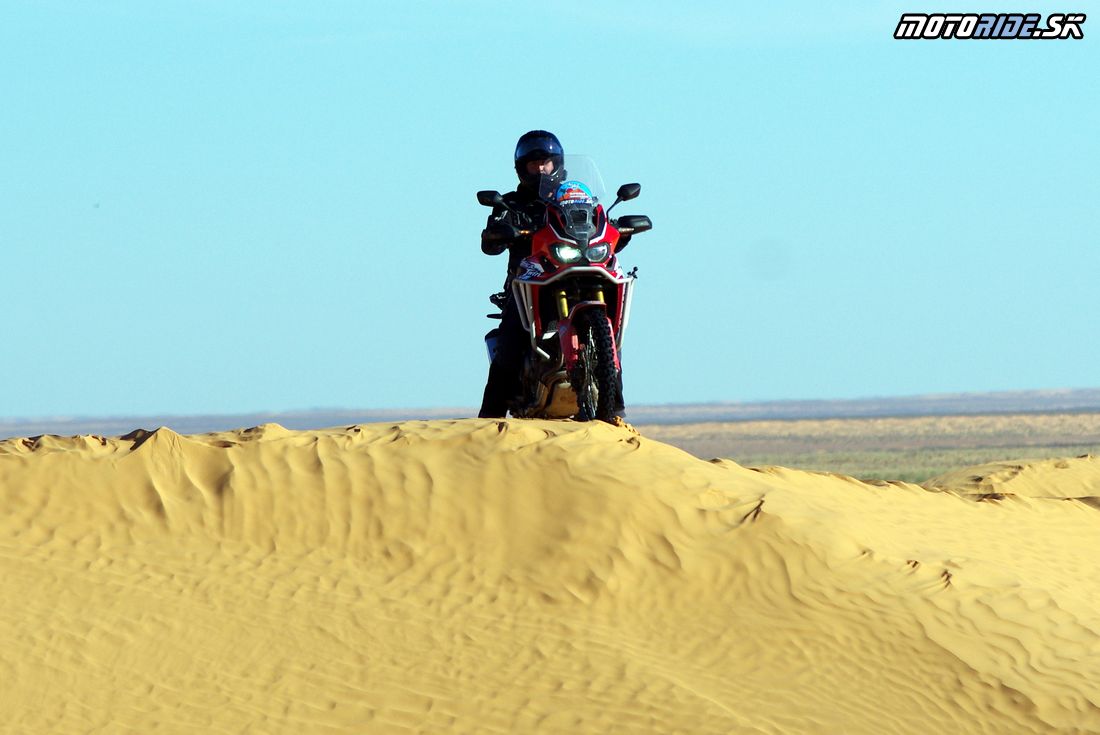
xmin=477 ymin=130 xmax=628 ymax=425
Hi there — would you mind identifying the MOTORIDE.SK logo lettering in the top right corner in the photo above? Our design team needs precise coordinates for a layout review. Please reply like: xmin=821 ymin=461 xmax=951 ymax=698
xmin=894 ymin=13 xmax=1085 ymax=41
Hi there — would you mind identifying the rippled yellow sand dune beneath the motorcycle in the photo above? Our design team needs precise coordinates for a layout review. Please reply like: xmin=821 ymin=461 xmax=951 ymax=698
xmin=0 ymin=420 xmax=1100 ymax=734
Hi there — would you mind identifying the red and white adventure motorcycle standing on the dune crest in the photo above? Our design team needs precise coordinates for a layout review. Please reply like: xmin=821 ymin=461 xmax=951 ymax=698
xmin=477 ymin=157 xmax=652 ymax=423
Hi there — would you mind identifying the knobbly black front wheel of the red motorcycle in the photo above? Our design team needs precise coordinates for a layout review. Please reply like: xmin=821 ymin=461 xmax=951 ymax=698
xmin=570 ymin=308 xmax=619 ymax=424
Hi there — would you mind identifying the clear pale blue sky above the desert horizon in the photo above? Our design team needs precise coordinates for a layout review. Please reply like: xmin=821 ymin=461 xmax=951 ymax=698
xmin=0 ymin=0 xmax=1100 ymax=417
